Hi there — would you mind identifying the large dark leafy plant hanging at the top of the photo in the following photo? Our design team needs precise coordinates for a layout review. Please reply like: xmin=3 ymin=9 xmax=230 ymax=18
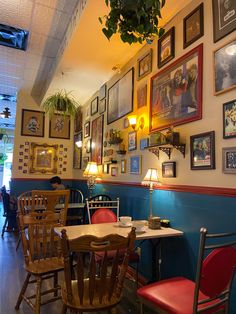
xmin=99 ymin=0 xmax=166 ymax=44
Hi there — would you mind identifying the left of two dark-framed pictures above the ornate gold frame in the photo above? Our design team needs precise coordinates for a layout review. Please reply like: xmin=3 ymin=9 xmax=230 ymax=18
xmin=21 ymin=109 xmax=45 ymax=137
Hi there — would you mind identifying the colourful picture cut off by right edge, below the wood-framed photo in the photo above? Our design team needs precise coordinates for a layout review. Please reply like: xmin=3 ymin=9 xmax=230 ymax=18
xmin=223 ymin=99 xmax=236 ymax=138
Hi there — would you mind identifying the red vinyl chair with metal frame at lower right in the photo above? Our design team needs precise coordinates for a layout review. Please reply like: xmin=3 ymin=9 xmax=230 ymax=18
xmin=137 ymin=228 xmax=236 ymax=314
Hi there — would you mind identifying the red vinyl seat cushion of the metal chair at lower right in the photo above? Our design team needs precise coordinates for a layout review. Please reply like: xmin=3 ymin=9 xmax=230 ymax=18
xmin=137 ymin=277 xmax=222 ymax=314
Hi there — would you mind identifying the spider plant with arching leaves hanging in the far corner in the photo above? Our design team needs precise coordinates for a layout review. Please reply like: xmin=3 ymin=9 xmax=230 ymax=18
xmin=41 ymin=90 xmax=80 ymax=117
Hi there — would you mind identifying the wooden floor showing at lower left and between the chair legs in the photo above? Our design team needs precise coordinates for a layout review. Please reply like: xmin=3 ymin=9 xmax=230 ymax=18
xmin=0 ymin=203 xmax=157 ymax=314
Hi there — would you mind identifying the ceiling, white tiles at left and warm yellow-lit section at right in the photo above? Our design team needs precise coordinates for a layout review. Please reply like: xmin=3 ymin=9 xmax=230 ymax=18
xmin=0 ymin=0 xmax=191 ymax=127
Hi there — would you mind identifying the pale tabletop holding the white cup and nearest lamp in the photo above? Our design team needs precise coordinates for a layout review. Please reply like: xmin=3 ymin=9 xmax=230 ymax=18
xmin=55 ymin=222 xmax=183 ymax=240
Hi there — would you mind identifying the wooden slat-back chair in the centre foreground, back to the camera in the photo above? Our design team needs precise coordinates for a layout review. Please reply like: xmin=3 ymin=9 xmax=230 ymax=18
xmin=61 ymin=228 xmax=135 ymax=313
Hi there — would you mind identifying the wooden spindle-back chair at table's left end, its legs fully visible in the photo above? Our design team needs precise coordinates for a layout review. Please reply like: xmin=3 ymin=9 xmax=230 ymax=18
xmin=15 ymin=211 xmax=64 ymax=314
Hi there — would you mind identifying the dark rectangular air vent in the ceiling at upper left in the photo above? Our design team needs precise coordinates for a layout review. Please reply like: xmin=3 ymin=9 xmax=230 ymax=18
xmin=0 ymin=24 xmax=29 ymax=50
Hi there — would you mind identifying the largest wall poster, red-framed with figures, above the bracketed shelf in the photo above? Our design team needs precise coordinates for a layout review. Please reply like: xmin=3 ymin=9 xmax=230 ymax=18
xmin=150 ymin=44 xmax=203 ymax=132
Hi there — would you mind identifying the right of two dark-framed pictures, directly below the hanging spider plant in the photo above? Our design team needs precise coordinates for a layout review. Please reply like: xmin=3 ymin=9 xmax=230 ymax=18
xmin=49 ymin=114 xmax=70 ymax=140
